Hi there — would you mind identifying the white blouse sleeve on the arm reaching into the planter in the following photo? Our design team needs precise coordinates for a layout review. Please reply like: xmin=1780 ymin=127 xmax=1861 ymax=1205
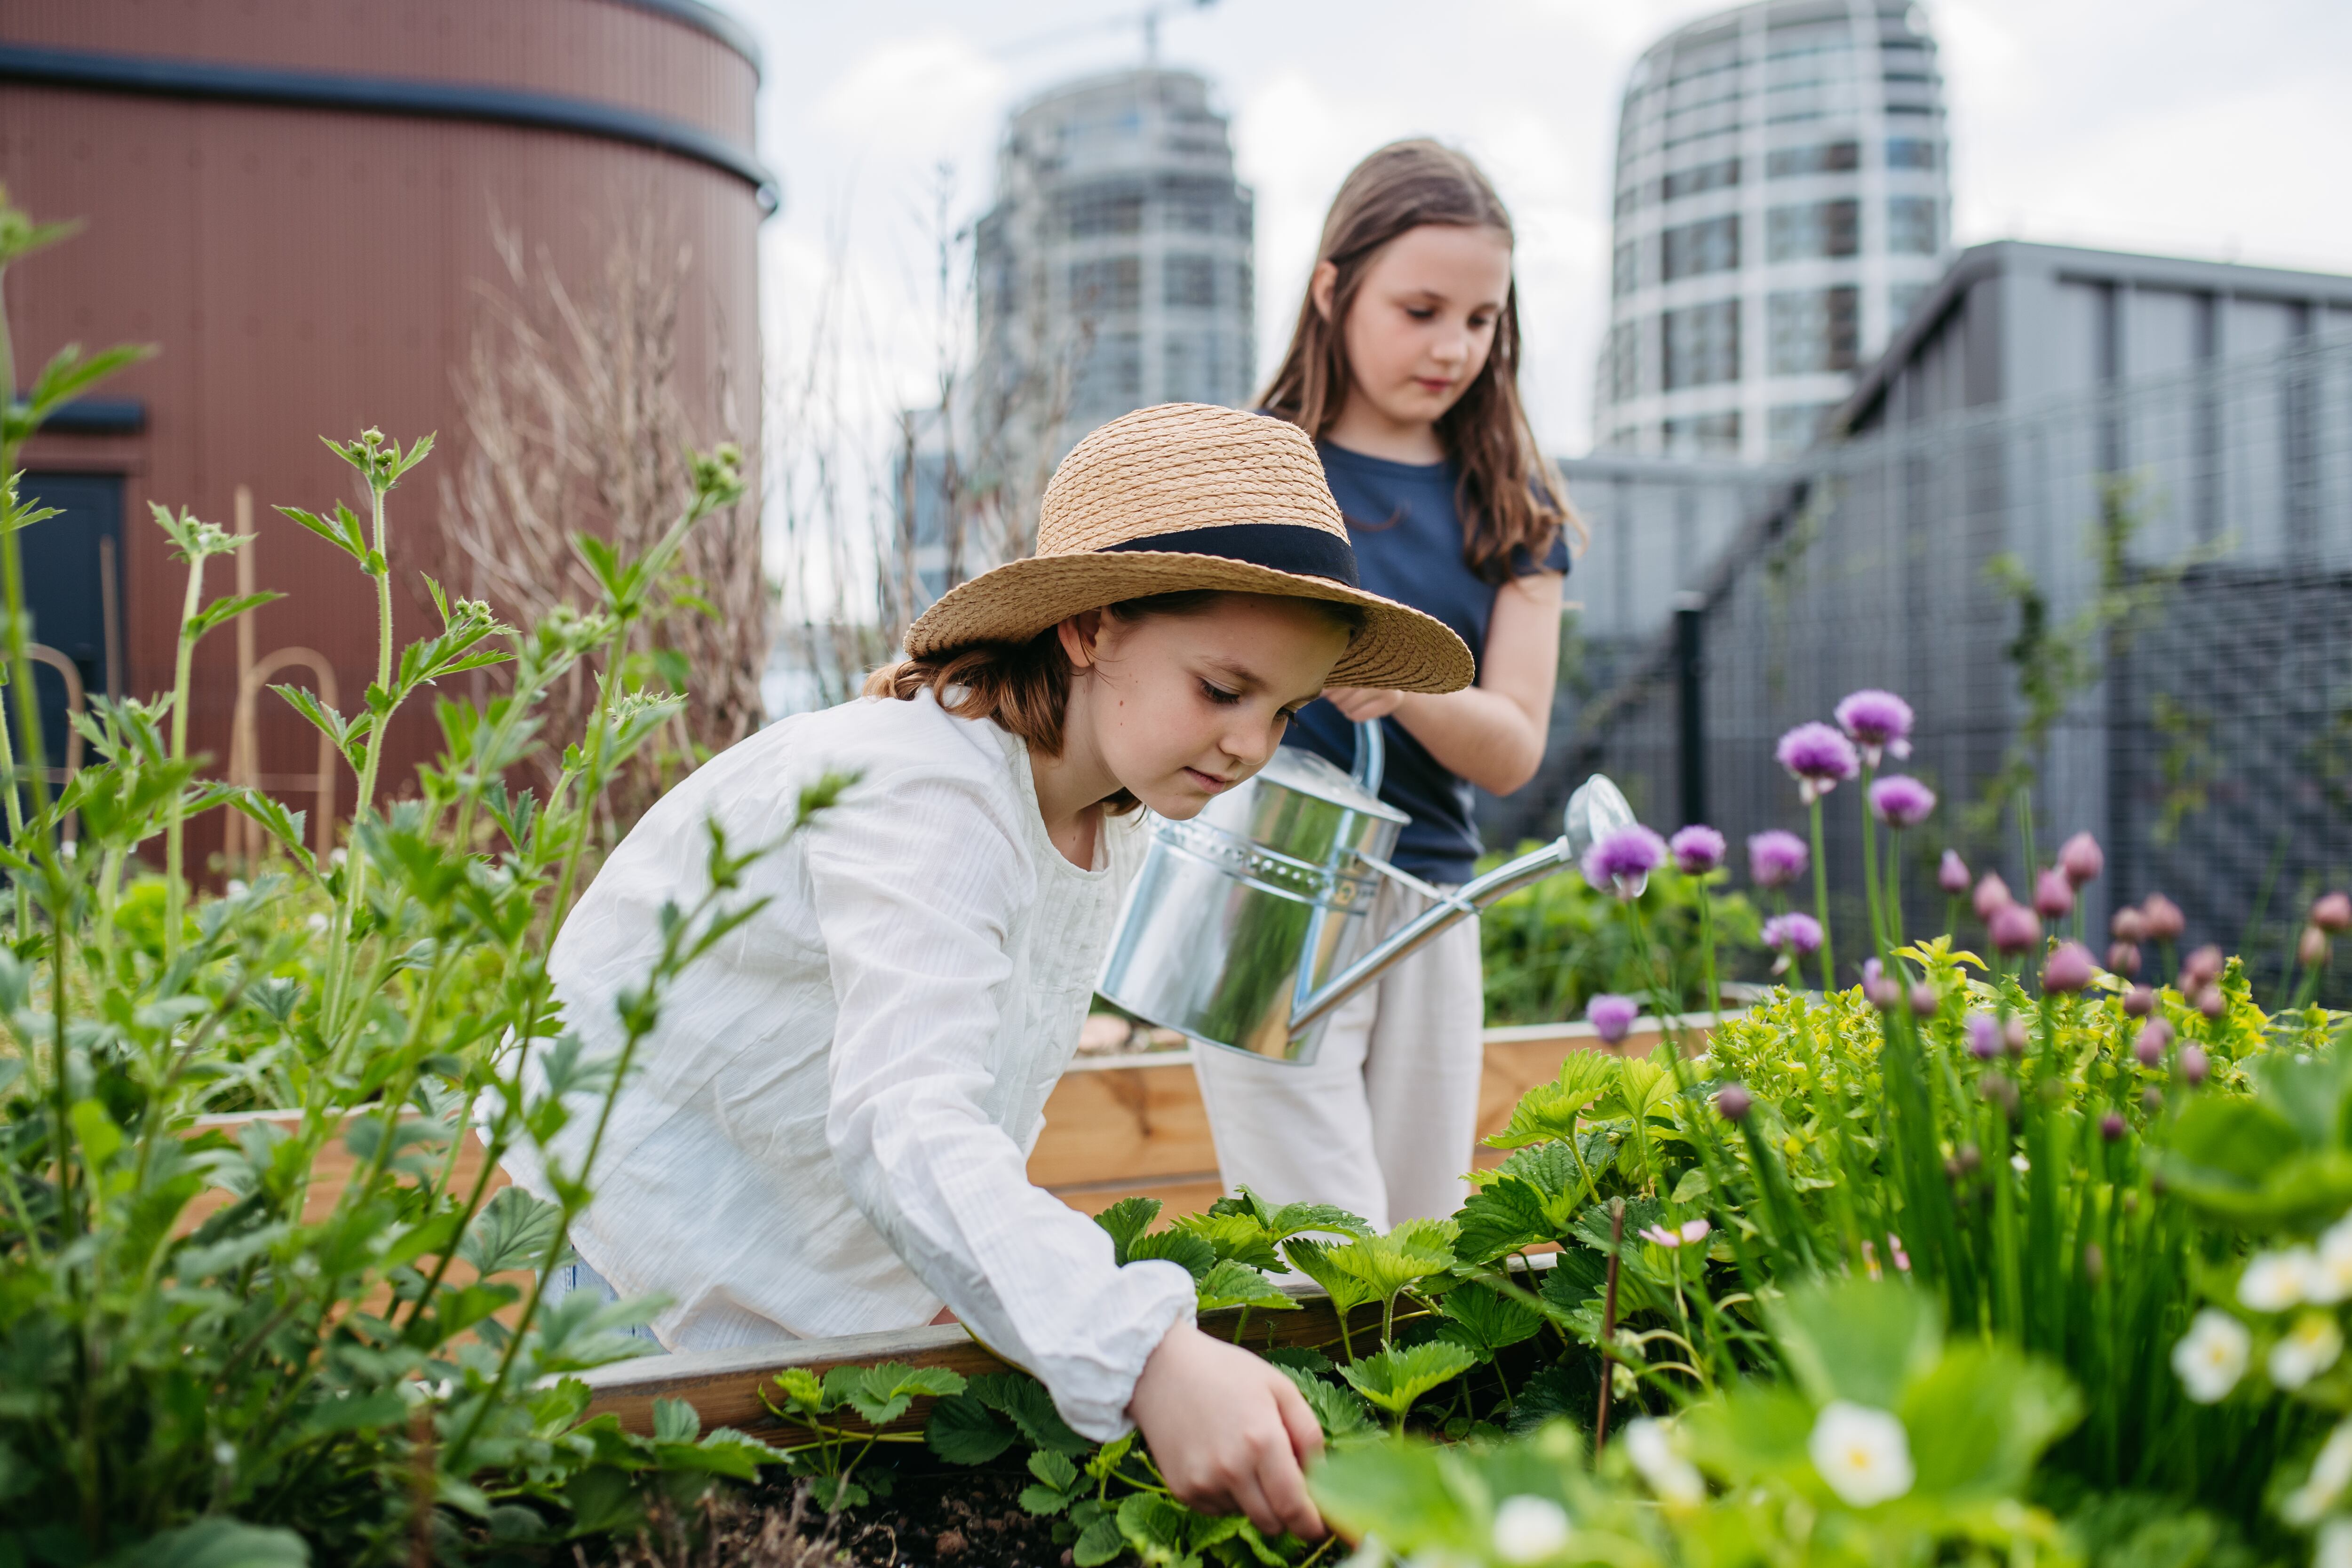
xmin=804 ymin=773 xmax=1195 ymax=1441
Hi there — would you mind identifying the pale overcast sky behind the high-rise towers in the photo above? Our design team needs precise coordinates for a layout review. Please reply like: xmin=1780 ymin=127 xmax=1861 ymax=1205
xmin=724 ymin=0 xmax=2352 ymax=472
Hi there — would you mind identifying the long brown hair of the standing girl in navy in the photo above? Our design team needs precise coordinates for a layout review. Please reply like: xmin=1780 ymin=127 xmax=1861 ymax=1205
xmin=1258 ymin=141 xmax=1588 ymax=583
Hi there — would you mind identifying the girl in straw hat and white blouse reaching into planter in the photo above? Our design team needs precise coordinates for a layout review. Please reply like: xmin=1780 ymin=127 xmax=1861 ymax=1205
xmin=508 ymin=404 xmax=1470 ymax=1535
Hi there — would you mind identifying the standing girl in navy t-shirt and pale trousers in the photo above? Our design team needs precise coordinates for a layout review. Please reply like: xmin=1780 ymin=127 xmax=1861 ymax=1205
xmin=1200 ymin=141 xmax=1583 ymax=1229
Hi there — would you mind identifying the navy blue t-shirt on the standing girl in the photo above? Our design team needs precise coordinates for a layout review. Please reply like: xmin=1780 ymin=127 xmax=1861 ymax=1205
xmin=1282 ymin=442 xmax=1569 ymax=882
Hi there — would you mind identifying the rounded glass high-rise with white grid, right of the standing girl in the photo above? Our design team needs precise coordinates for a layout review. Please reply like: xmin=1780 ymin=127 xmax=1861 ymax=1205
xmin=1592 ymin=0 xmax=1952 ymax=458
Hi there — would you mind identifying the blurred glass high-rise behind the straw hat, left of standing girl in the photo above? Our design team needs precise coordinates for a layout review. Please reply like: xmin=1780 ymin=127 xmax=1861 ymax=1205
xmin=976 ymin=66 xmax=1256 ymax=491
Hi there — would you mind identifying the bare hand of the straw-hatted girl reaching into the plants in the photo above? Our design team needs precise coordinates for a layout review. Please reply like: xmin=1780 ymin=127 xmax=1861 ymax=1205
xmin=1127 ymin=1321 xmax=1324 ymax=1540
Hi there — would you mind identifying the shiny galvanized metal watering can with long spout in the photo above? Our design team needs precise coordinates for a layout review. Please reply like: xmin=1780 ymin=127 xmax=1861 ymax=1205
xmin=1096 ymin=724 xmax=1635 ymax=1065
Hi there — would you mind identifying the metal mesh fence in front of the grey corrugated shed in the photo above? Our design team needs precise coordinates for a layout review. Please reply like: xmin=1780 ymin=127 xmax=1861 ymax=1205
xmin=1531 ymin=339 xmax=2352 ymax=999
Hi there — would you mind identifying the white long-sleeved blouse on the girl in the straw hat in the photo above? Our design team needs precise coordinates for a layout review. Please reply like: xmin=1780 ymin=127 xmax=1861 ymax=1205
xmin=506 ymin=693 xmax=1192 ymax=1439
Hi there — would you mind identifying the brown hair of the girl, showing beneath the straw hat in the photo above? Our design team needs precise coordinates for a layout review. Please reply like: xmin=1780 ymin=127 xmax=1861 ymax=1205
xmin=863 ymin=588 xmax=1364 ymax=816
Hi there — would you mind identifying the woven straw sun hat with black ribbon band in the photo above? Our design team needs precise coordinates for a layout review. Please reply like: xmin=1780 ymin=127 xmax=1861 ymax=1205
xmin=906 ymin=402 xmax=1475 ymax=691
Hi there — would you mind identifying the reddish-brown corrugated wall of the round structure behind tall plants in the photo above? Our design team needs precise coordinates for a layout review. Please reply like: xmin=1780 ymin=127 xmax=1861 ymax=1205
xmin=0 ymin=0 xmax=762 ymax=849
